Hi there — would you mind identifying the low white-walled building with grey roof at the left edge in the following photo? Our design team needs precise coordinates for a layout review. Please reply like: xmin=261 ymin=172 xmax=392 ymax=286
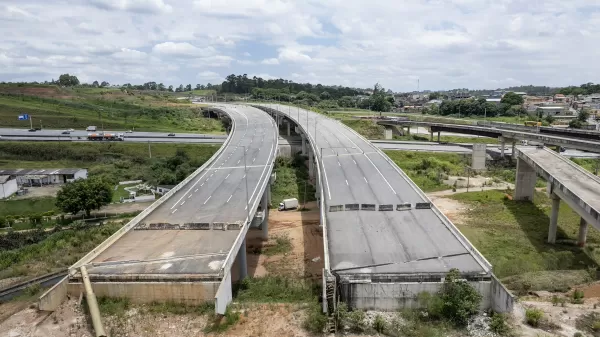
xmin=0 ymin=168 xmax=87 ymax=186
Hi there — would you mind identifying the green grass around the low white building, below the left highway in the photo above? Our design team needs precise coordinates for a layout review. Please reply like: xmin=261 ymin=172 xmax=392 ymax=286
xmin=0 ymin=142 xmax=219 ymax=216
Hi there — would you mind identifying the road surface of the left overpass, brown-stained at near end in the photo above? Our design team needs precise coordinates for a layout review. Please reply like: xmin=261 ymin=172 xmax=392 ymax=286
xmin=88 ymin=106 xmax=277 ymax=274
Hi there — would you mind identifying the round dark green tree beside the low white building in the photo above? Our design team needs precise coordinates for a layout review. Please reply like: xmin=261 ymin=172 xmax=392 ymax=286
xmin=56 ymin=177 xmax=113 ymax=216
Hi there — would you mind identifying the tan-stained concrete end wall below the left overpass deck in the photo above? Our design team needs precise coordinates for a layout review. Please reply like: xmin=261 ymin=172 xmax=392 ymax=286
xmin=67 ymin=282 xmax=220 ymax=305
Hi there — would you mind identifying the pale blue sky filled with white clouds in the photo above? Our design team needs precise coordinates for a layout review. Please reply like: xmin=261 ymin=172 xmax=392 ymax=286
xmin=0 ymin=0 xmax=600 ymax=91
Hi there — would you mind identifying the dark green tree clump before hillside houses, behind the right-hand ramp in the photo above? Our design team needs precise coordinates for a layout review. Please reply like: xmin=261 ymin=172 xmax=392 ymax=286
xmin=423 ymin=98 xmax=527 ymax=117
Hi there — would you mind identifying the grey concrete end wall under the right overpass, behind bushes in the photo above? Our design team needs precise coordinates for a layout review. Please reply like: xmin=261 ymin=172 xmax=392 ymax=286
xmin=340 ymin=281 xmax=492 ymax=311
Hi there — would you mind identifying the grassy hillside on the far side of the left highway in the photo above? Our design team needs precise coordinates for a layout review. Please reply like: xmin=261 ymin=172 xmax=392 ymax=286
xmin=0 ymin=85 xmax=225 ymax=134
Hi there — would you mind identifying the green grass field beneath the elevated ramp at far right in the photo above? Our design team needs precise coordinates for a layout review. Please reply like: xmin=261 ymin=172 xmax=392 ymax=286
xmin=450 ymin=191 xmax=600 ymax=291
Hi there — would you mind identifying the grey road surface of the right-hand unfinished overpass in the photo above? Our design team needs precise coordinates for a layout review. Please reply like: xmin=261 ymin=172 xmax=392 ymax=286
xmin=258 ymin=105 xmax=486 ymax=275
